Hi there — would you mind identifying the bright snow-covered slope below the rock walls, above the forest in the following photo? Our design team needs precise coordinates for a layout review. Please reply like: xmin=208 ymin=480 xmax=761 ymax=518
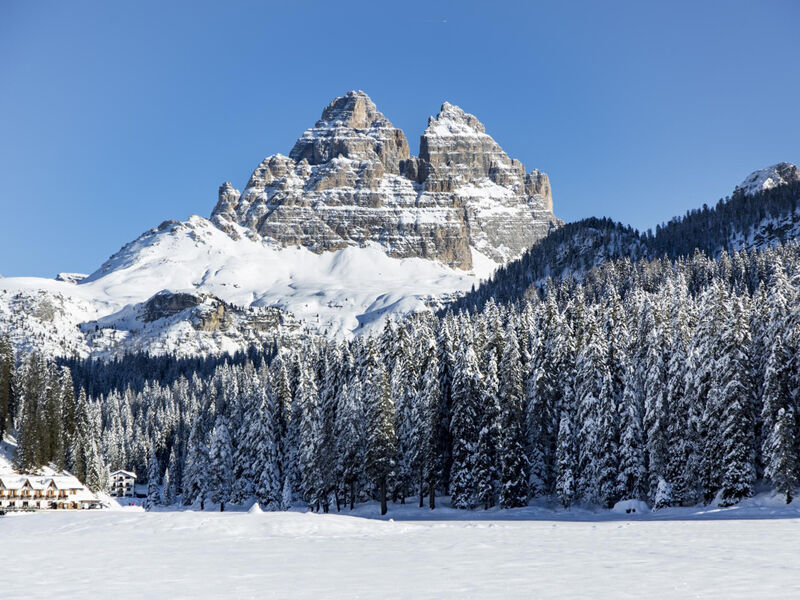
xmin=0 ymin=216 xmax=495 ymax=356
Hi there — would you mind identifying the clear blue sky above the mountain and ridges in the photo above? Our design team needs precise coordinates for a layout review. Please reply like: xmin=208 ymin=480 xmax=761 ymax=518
xmin=0 ymin=0 xmax=800 ymax=277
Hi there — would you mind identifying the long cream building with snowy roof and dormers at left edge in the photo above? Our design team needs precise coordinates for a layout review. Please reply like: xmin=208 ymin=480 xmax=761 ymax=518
xmin=0 ymin=473 xmax=100 ymax=510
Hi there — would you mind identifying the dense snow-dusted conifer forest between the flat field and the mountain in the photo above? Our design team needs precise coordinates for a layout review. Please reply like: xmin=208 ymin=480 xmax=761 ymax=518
xmin=6 ymin=237 xmax=800 ymax=512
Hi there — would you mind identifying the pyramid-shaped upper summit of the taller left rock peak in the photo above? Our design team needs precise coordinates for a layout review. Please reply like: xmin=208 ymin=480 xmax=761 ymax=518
xmin=289 ymin=91 xmax=409 ymax=173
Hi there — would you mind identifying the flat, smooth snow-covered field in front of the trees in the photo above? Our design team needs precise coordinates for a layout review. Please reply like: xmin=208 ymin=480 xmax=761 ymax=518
xmin=0 ymin=497 xmax=800 ymax=598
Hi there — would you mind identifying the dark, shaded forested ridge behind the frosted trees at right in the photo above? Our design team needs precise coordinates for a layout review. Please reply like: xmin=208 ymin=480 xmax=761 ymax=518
xmin=452 ymin=182 xmax=800 ymax=311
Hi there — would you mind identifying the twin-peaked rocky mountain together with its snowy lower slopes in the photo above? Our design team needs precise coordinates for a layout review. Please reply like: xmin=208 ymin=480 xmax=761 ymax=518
xmin=0 ymin=92 xmax=560 ymax=356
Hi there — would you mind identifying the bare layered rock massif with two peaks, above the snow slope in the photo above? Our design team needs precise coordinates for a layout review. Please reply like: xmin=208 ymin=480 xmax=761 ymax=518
xmin=212 ymin=92 xmax=558 ymax=269
